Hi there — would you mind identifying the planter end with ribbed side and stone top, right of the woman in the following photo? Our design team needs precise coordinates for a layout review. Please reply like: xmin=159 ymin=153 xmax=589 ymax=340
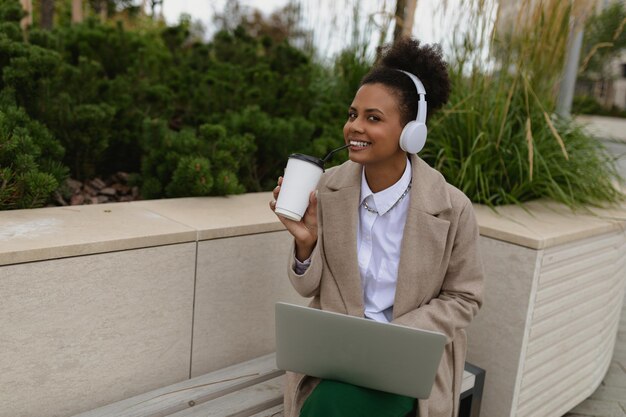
xmin=468 ymin=203 xmax=626 ymax=417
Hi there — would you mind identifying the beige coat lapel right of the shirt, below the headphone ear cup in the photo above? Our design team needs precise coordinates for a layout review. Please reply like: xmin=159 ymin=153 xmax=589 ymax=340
xmin=393 ymin=155 xmax=452 ymax=318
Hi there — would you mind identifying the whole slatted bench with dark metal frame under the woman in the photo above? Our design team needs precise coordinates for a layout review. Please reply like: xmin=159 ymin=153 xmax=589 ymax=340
xmin=75 ymin=354 xmax=485 ymax=417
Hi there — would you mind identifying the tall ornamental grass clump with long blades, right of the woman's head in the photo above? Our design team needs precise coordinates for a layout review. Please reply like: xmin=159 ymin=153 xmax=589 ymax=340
xmin=422 ymin=0 xmax=625 ymax=208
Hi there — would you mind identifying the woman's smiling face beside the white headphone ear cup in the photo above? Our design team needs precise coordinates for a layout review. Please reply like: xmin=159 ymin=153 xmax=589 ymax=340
xmin=343 ymin=84 xmax=406 ymax=168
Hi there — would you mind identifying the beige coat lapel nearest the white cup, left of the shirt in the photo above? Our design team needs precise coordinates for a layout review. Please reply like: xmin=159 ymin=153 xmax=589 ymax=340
xmin=320 ymin=163 xmax=364 ymax=317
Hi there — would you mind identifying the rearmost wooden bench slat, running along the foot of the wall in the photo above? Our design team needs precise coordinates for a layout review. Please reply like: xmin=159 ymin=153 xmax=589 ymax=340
xmin=75 ymin=353 xmax=283 ymax=417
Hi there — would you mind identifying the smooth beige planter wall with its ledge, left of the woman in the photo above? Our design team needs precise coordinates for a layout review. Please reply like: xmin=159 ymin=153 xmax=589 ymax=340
xmin=0 ymin=194 xmax=307 ymax=417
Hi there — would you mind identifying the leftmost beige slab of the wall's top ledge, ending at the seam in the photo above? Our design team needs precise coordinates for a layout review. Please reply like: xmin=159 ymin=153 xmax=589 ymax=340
xmin=0 ymin=203 xmax=196 ymax=265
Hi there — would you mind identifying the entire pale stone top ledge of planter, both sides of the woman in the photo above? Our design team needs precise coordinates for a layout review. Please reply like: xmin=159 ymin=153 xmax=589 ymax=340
xmin=0 ymin=192 xmax=626 ymax=265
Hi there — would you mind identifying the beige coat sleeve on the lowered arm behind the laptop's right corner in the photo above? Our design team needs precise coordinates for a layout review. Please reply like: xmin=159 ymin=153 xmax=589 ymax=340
xmin=393 ymin=200 xmax=483 ymax=343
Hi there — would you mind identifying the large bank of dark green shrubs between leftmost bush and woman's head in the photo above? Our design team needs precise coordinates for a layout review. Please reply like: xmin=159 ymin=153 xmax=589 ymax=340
xmin=0 ymin=0 xmax=369 ymax=207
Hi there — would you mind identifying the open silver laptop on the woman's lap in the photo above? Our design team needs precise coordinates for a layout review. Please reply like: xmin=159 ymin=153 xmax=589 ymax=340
xmin=276 ymin=303 xmax=446 ymax=399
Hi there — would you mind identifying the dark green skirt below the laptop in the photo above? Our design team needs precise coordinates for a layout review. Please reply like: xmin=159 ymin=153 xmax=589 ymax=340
xmin=300 ymin=379 xmax=417 ymax=417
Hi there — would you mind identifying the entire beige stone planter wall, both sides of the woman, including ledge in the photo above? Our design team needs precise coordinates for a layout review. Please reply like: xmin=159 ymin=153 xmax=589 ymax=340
xmin=0 ymin=193 xmax=626 ymax=417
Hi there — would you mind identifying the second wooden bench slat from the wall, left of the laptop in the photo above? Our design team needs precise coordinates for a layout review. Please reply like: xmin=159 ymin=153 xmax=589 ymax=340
xmin=170 ymin=376 xmax=284 ymax=417
